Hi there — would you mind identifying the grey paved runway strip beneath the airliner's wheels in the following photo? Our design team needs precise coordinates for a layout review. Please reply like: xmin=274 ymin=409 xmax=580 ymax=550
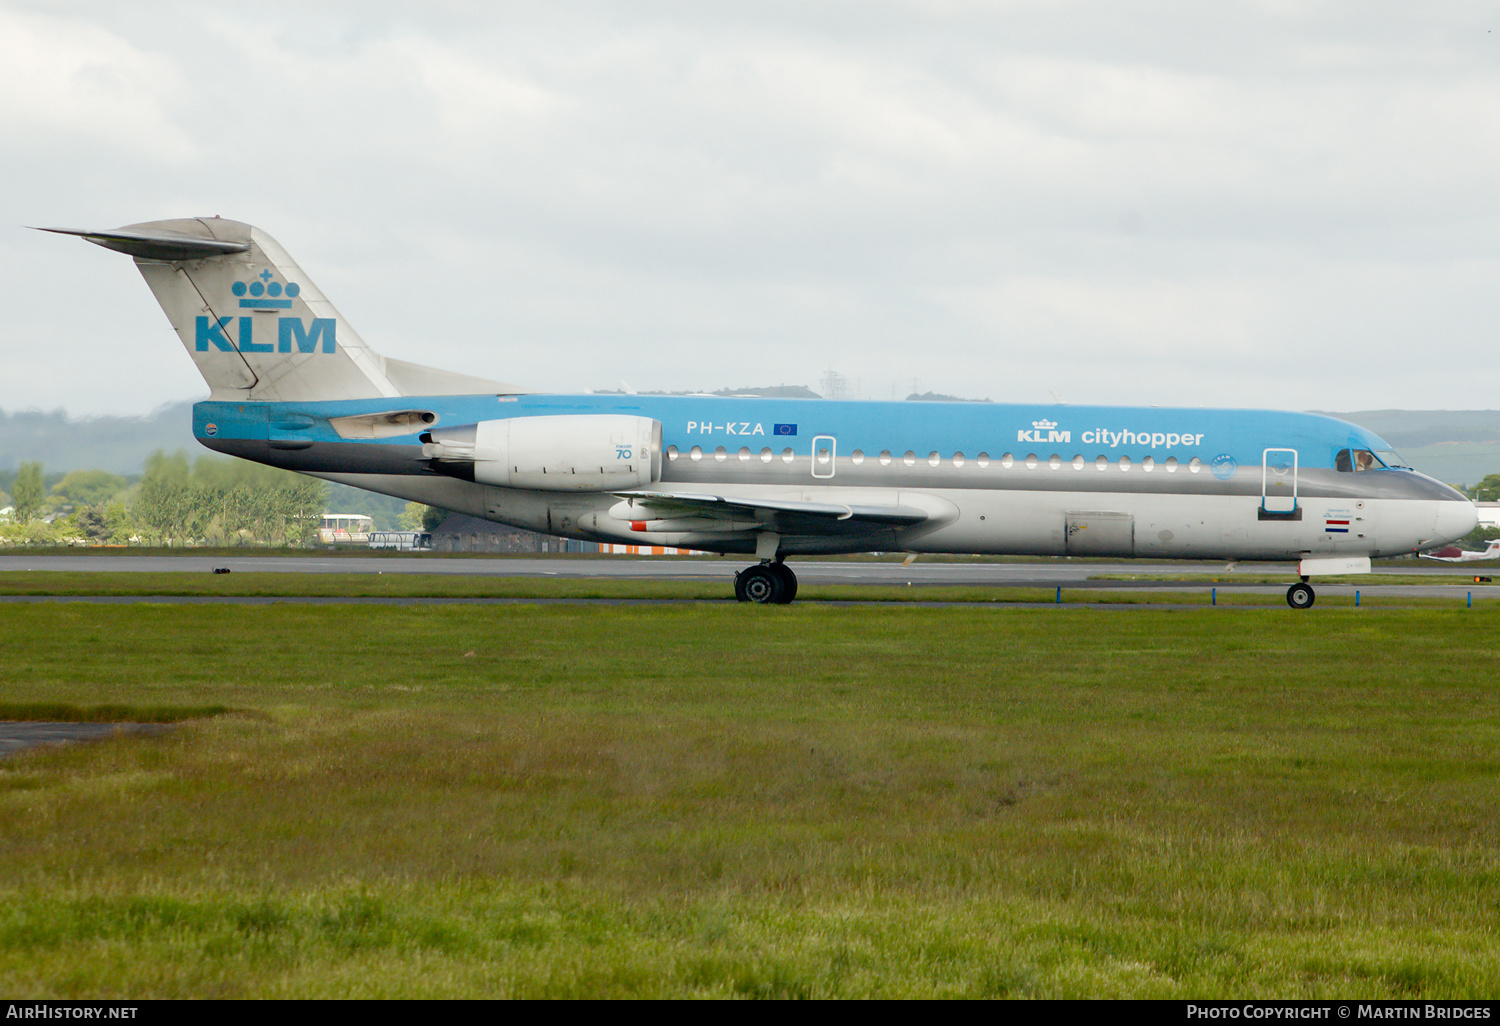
xmin=0 ymin=554 xmax=1500 ymax=602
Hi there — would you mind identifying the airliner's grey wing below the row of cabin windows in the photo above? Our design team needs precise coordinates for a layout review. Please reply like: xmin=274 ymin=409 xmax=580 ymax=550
xmin=611 ymin=492 xmax=930 ymax=536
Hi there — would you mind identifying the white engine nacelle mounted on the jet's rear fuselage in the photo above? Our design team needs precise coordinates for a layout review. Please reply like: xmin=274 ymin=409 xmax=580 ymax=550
xmin=422 ymin=414 xmax=662 ymax=492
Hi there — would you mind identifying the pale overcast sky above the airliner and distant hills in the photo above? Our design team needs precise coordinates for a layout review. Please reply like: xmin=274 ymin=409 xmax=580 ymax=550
xmin=0 ymin=0 xmax=1500 ymax=414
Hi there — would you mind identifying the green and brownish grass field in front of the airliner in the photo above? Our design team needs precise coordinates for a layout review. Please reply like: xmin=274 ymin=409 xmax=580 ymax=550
xmin=0 ymin=597 xmax=1500 ymax=998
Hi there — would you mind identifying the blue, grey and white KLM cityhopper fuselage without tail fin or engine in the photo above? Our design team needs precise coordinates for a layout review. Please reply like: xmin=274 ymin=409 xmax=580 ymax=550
xmin=194 ymin=395 xmax=1475 ymax=560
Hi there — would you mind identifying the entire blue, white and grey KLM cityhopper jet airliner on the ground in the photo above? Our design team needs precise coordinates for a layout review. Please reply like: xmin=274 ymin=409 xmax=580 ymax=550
xmin=48 ymin=218 xmax=1476 ymax=609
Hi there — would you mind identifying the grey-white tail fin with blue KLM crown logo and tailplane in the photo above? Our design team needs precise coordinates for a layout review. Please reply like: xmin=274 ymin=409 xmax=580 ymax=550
xmin=42 ymin=218 xmax=527 ymax=402
